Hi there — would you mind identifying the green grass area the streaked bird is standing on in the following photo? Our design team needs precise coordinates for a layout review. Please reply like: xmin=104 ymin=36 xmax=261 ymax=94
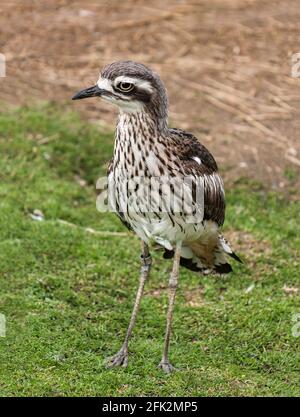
xmin=0 ymin=105 xmax=300 ymax=396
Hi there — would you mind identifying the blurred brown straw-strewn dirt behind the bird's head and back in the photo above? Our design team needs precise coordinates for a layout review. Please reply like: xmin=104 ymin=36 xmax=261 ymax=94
xmin=0 ymin=0 xmax=300 ymax=188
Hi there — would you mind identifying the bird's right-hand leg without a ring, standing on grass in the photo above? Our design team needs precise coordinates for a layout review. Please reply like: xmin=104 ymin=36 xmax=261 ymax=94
xmin=159 ymin=243 xmax=181 ymax=374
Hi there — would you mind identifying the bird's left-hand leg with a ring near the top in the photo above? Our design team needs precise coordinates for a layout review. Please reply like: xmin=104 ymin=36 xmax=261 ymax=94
xmin=107 ymin=242 xmax=152 ymax=368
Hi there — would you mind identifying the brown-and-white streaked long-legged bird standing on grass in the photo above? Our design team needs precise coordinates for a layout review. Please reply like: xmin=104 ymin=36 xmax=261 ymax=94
xmin=72 ymin=60 xmax=242 ymax=374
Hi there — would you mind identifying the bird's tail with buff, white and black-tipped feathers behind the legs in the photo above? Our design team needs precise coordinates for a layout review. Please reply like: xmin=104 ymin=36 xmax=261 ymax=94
xmin=164 ymin=234 xmax=242 ymax=274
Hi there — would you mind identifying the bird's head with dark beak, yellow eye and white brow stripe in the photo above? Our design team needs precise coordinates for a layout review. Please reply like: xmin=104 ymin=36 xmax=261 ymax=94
xmin=72 ymin=61 xmax=168 ymax=128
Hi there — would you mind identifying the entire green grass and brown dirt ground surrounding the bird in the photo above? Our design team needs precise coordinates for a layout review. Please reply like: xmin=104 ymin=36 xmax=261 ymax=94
xmin=0 ymin=0 xmax=300 ymax=396
